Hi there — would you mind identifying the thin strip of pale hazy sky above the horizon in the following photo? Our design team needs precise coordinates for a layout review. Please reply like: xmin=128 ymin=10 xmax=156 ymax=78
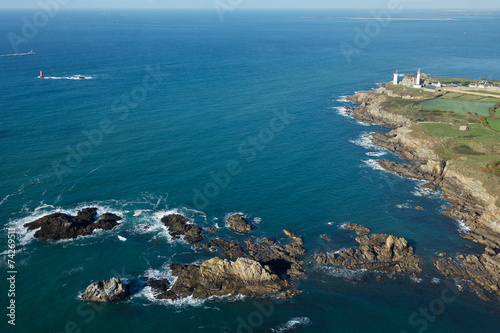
xmin=0 ymin=0 xmax=500 ymax=10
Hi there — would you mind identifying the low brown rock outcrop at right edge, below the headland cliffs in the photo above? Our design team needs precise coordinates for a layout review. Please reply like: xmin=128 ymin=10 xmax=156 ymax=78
xmin=434 ymin=252 xmax=500 ymax=300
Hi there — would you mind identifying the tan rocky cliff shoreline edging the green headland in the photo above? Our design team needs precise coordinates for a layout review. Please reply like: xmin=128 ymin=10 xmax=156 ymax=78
xmin=348 ymin=86 xmax=500 ymax=299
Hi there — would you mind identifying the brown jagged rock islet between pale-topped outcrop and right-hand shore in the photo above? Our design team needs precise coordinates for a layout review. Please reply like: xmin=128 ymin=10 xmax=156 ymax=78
xmin=314 ymin=234 xmax=422 ymax=274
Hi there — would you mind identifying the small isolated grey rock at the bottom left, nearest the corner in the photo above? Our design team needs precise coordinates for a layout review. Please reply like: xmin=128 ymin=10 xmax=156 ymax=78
xmin=82 ymin=277 xmax=130 ymax=303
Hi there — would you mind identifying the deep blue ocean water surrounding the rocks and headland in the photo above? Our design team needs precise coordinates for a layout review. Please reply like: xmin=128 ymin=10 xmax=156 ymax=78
xmin=0 ymin=10 xmax=500 ymax=332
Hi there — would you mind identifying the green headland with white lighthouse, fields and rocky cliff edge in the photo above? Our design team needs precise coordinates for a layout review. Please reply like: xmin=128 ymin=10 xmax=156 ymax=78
xmin=348 ymin=70 xmax=500 ymax=299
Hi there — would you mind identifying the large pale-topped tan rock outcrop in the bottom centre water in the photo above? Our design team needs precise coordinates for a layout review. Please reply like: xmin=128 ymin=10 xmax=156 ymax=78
xmin=160 ymin=257 xmax=293 ymax=300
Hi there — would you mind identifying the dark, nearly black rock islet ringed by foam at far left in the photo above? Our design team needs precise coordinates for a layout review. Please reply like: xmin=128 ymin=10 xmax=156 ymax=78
xmin=24 ymin=208 xmax=122 ymax=240
